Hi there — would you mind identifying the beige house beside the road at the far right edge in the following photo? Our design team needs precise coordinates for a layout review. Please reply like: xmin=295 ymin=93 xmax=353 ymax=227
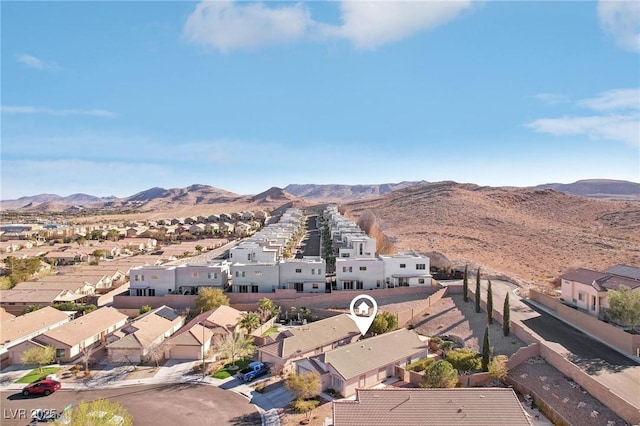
xmin=560 ymin=265 xmax=640 ymax=317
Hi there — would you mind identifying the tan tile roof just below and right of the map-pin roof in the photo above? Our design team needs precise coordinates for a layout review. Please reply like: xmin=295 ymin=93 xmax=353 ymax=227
xmin=314 ymin=328 xmax=428 ymax=380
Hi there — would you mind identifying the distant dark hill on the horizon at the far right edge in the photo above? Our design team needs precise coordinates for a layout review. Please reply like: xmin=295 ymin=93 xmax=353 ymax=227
xmin=536 ymin=179 xmax=640 ymax=200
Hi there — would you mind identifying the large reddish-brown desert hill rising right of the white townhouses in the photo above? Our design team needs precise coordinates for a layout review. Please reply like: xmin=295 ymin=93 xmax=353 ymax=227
xmin=344 ymin=182 xmax=640 ymax=283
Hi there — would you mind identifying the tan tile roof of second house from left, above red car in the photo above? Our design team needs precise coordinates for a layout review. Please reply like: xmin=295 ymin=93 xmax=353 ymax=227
xmin=39 ymin=307 xmax=128 ymax=346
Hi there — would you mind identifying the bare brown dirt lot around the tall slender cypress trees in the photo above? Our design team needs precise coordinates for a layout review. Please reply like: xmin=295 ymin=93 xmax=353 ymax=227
xmin=413 ymin=294 xmax=526 ymax=356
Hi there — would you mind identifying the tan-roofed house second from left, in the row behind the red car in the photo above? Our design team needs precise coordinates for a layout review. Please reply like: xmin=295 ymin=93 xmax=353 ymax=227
xmin=33 ymin=307 xmax=128 ymax=362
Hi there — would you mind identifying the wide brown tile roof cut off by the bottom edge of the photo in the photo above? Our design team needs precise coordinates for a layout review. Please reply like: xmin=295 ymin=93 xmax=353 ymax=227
xmin=333 ymin=387 xmax=531 ymax=426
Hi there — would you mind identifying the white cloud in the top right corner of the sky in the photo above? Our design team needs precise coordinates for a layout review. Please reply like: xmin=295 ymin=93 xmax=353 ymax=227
xmin=598 ymin=0 xmax=640 ymax=52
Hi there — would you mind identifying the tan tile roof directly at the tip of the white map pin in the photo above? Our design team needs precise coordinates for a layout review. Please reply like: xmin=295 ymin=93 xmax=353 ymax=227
xmin=260 ymin=314 xmax=360 ymax=359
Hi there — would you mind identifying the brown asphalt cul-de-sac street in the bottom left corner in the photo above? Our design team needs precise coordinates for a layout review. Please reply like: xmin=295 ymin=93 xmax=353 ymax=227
xmin=0 ymin=384 xmax=261 ymax=426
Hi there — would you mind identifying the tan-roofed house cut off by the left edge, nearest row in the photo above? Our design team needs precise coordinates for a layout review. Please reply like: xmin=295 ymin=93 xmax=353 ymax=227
xmin=0 ymin=306 xmax=70 ymax=368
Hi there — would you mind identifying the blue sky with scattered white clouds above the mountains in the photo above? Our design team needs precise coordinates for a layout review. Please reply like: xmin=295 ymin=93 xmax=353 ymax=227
xmin=0 ymin=1 xmax=640 ymax=199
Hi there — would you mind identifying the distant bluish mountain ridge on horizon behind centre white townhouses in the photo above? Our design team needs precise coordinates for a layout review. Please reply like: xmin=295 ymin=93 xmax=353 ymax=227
xmin=284 ymin=181 xmax=425 ymax=202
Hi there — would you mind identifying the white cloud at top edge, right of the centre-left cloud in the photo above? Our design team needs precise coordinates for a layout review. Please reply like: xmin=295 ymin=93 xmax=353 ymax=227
xmin=325 ymin=1 xmax=471 ymax=49
